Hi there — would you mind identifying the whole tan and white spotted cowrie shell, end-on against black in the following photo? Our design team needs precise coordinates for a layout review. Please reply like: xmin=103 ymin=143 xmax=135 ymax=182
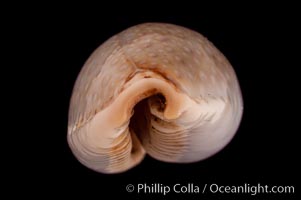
xmin=67 ymin=23 xmax=243 ymax=173
